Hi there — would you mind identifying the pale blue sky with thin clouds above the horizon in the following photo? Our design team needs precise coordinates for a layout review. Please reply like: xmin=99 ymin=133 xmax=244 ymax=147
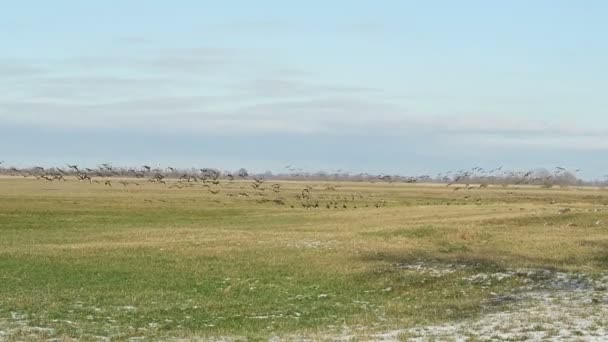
xmin=0 ymin=0 xmax=608 ymax=179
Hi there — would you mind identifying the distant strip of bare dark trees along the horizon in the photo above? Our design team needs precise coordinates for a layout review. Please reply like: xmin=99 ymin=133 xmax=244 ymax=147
xmin=0 ymin=164 xmax=608 ymax=188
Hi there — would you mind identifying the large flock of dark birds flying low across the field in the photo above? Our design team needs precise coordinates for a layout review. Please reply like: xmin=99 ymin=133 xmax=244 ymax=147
xmin=0 ymin=161 xmax=592 ymax=209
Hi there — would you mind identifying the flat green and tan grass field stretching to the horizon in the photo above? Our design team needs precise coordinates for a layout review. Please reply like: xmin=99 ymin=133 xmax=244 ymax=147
xmin=0 ymin=178 xmax=608 ymax=340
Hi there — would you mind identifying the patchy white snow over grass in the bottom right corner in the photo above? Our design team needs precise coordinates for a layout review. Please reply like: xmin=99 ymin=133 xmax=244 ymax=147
xmin=378 ymin=270 xmax=608 ymax=341
